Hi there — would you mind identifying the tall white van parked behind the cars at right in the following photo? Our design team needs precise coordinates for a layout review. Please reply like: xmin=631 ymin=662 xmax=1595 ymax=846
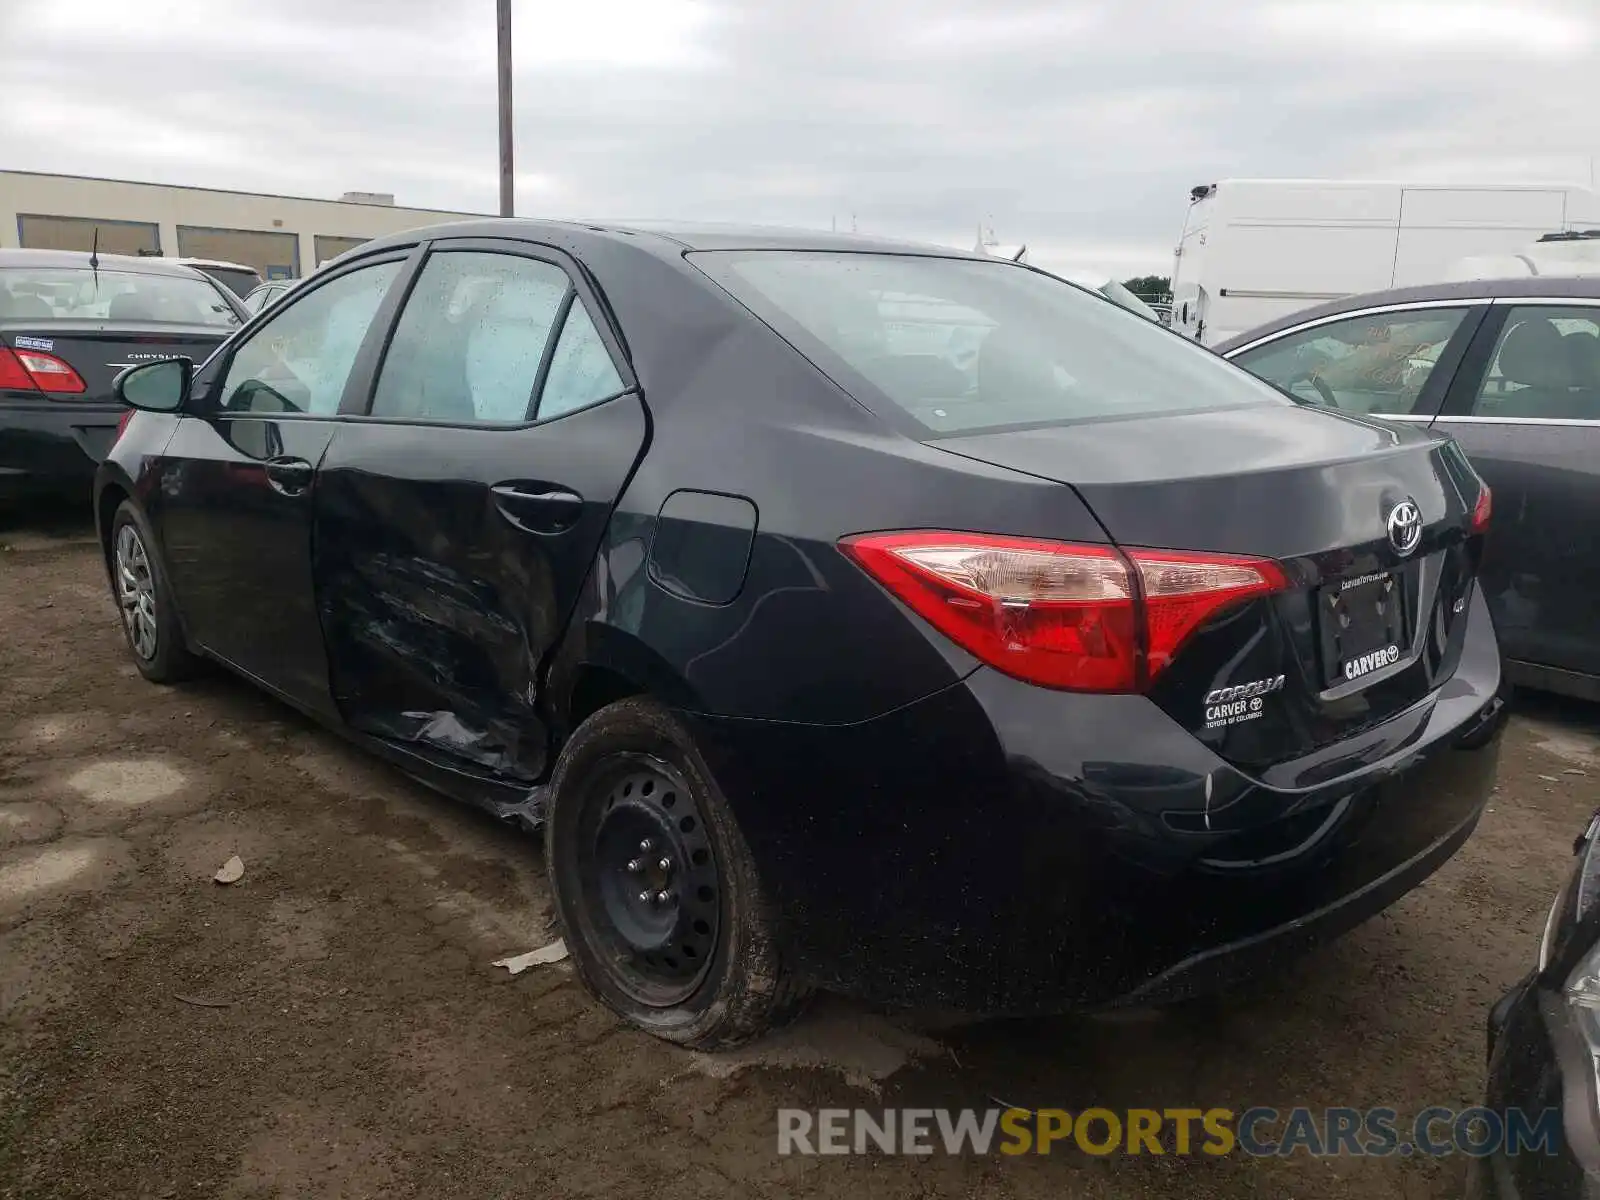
xmin=1173 ymin=179 xmax=1600 ymax=346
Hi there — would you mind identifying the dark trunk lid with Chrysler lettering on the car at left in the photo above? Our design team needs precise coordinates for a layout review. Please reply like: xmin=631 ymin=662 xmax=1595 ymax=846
xmin=0 ymin=318 xmax=230 ymax=405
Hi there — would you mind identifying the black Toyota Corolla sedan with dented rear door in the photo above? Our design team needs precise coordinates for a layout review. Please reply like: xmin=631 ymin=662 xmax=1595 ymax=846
xmin=98 ymin=221 xmax=1502 ymax=1046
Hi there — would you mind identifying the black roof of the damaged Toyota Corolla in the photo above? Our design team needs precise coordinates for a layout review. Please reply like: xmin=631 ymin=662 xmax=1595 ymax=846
xmin=349 ymin=218 xmax=984 ymax=259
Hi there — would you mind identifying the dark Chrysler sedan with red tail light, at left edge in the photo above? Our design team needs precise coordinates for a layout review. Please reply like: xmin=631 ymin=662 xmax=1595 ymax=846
xmin=0 ymin=250 xmax=243 ymax=501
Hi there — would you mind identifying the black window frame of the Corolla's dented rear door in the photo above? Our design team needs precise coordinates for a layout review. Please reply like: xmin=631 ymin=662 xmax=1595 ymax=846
xmin=339 ymin=237 xmax=640 ymax=430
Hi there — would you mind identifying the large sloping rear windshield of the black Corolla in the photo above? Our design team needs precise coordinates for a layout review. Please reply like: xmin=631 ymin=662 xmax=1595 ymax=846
xmin=691 ymin=251 xmax=1293 ymax=437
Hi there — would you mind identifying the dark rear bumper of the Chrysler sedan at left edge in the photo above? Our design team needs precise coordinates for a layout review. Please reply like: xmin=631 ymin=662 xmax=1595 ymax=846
xmin=0 ymin=398 xmax=123 ymax=496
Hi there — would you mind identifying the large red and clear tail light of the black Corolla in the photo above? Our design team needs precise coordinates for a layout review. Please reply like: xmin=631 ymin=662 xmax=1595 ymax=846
xmin=840 ymin=531 xmax=1286 ymax=691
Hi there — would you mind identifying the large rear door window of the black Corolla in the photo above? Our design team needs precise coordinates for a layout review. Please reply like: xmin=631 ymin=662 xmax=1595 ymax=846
xmin=373 ymin=250 xmax=570 ymax=422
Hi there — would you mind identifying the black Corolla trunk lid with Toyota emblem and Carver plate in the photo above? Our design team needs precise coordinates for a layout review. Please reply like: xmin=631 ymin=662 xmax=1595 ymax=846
xmin=933 ymin=406 xmax=1482 ymax=768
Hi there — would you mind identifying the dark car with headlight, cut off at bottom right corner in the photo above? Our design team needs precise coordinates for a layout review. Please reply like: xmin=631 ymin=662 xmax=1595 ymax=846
xmin=1467 ymin=813 xmax=1600 ymax=1200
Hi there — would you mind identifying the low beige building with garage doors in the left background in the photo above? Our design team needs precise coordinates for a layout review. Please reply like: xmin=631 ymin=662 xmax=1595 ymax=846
xmin=0 ymin=171 xmax=485 ymax=278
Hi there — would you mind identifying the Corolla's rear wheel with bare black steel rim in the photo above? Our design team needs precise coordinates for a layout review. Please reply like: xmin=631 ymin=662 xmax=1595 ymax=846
xmin=544 ymin=698 xmax=808 ymax=1050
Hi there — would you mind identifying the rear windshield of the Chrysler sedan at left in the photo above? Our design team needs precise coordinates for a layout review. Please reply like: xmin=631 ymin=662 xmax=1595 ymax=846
xmin=0 ymin=267 xmax=238 ymax=330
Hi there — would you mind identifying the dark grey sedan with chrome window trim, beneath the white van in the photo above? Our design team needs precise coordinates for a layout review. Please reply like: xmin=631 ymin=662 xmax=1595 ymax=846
xmin=1216 ymin=278 xmax=1600 ymax=699
